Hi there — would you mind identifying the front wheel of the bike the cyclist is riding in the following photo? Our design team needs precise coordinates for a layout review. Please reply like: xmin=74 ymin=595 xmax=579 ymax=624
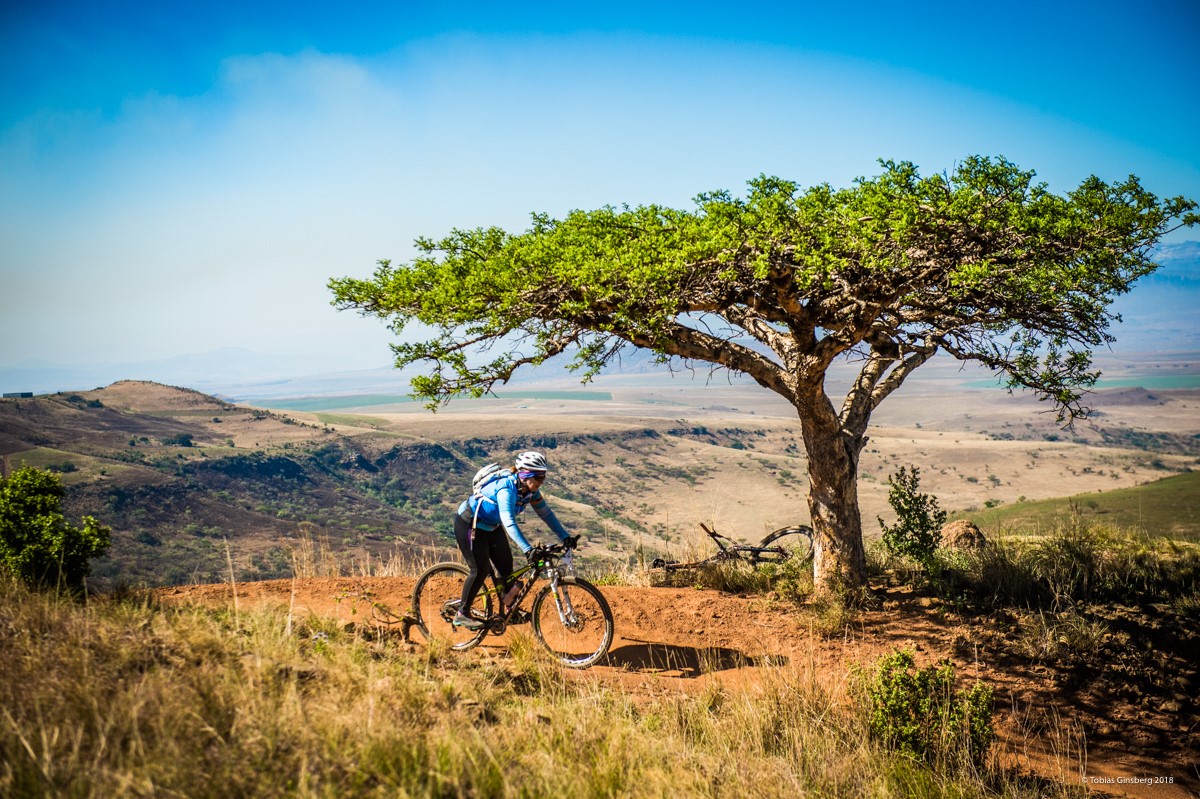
xmin=533 ymin=577 xmax=613 ymax=668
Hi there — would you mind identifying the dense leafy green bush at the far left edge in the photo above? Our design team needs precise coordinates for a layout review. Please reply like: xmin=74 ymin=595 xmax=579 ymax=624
xmin=0 ymin=467 xmax=110 ymax=589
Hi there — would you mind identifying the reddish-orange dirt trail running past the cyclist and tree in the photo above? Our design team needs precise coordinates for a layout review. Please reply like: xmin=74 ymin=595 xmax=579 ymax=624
xmin=156 ymin=577 xmax=1200 ymax=799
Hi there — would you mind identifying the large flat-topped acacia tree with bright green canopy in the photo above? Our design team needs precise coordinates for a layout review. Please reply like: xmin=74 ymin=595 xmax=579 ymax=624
xmin=330 ymin=157 xmax=1200 ymax=588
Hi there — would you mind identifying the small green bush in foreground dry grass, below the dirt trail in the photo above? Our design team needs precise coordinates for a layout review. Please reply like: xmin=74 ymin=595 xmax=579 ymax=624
xmin=856 ymin=649 xmax=996 ymax=768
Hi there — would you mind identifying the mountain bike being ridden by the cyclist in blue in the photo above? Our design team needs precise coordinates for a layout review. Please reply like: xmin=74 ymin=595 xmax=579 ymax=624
xmin=412 ymin=545 xmax=613 ymax=668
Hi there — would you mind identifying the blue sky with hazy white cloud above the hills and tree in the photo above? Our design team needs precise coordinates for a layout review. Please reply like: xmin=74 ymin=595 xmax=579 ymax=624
xmin=0 ymin=0 xmax=1200 ymax=371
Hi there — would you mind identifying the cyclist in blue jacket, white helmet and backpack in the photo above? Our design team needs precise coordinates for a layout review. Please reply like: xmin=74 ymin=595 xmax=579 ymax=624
xmin=454 ymin=451 xmax=578 ymax=630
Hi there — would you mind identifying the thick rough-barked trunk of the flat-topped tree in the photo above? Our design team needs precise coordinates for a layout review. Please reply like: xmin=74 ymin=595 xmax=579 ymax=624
xmin=799 ymin=391 xmax=866 ymax=593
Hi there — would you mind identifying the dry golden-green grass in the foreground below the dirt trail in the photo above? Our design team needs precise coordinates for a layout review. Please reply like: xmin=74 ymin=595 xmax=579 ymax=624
xmin=0 ymin=582 xmax=1078 ymax=799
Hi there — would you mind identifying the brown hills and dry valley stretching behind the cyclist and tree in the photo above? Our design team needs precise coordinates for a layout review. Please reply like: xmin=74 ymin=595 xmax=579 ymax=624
xmin=0 ymin=378 xmax=1195 ymax=587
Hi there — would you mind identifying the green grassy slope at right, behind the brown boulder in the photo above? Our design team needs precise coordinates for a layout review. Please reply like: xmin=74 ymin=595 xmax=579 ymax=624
xmin=954 ymin=471 xmax=1200 ymax=541
